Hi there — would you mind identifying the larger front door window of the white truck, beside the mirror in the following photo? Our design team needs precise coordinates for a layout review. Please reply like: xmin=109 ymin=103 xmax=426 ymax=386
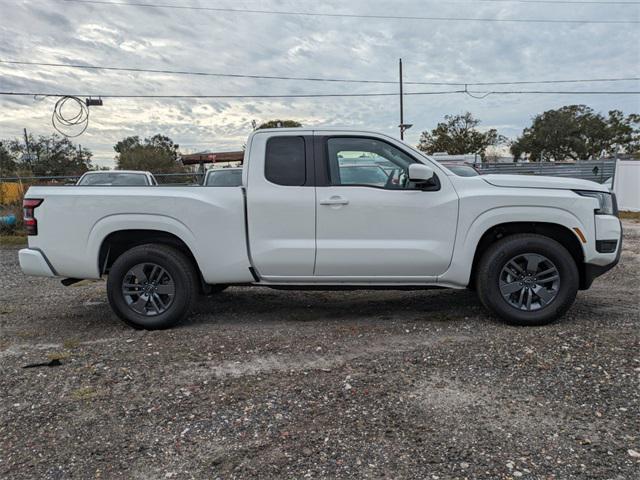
xmin=327 ymin=137 xmax=415 ymax=190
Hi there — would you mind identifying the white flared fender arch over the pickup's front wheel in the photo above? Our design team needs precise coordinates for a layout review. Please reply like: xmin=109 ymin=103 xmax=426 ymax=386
xmin=438 ymin=206 xmax=591 ymax=287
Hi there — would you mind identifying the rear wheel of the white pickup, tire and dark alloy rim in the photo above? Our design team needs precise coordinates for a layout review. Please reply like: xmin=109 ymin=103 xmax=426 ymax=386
xmin=107 ymin=244 xmax=199 ymax=330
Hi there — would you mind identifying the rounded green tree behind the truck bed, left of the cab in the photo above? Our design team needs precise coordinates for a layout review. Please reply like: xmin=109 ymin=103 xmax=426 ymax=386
xmin=113 ymin=134 xmax=182 ymax=173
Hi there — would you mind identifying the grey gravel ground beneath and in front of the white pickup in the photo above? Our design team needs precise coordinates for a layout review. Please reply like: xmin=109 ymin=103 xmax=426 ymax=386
xmin=0 ymin=221 xmax=640 ymax=479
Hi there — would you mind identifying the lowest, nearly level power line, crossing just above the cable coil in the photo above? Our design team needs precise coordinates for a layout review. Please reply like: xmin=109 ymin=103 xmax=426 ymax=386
xmin=0 ymin=90 xmax=640 ymax=99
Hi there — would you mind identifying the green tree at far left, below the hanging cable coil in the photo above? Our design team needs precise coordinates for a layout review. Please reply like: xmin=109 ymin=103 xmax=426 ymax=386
xmin=9 ymin=133 xmax=93 ymax=176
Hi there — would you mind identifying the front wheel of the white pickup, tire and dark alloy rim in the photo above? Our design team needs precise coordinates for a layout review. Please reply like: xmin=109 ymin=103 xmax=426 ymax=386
xmin=476 ymin=234 xmax=580 ymax=326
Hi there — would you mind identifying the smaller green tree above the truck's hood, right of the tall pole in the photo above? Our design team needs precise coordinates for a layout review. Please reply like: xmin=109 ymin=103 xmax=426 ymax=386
xmin=418 ymin=112 xmax=506 ymax=159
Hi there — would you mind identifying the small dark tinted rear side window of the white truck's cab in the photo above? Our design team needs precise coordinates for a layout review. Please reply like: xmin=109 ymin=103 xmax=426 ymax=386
xmin=264 ymin=136 xmax=307 ymax=187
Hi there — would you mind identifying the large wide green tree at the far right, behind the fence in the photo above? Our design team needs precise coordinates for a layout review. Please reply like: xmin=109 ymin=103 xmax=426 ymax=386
xmin=511 ymin=105 xmax=640 ymax=161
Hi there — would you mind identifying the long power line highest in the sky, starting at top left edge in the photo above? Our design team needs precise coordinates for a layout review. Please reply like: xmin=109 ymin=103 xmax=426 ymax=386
xmin=62 ymin=0 xmax=640 ymax=24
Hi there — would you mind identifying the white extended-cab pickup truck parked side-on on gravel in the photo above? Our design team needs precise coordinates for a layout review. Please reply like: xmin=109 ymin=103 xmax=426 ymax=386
xmin=19 ymin=129 xmax=622 ymax=329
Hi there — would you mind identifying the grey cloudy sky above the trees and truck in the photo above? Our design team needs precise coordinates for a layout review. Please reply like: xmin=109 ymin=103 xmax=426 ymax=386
xmin=0 ymin=0 xmax=640 ymax=166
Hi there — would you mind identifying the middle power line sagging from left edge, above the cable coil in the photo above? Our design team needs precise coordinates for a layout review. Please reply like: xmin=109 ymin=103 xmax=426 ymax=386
xmin=0 ymin=60 xmax=640 ymax=87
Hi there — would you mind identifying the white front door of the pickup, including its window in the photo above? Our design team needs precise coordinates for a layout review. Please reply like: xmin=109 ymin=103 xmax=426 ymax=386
xmin=314 ymin=133 xmax=458 ymax=282
